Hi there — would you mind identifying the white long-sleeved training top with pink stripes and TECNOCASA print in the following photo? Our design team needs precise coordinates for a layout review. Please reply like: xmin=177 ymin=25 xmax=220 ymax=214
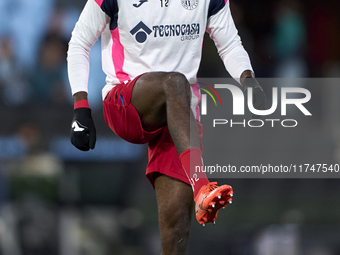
xmin=67 ymin=0 xmax=252 ymax=119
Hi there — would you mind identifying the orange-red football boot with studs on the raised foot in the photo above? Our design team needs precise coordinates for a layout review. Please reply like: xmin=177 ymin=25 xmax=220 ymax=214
xmin=195 ymin=182 xmax=233 ymax=227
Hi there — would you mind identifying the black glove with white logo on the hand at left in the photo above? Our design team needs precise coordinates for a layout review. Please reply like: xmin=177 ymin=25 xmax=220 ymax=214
xmin=71 ymin=108 xmax=96 ymax=151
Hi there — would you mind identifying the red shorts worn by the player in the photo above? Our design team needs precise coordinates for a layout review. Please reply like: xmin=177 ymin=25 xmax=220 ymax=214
xmin=103 ymin=77 xmax=203 ymax=186
